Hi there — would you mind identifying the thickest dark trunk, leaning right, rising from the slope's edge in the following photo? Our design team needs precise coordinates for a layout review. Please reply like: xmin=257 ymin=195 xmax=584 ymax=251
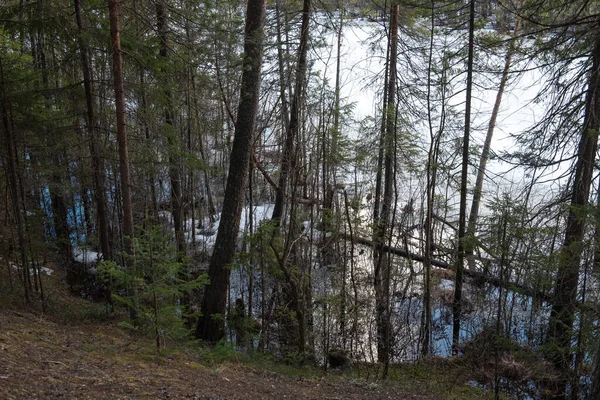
xmin=196 ymin=0 xmax=265 ymax=343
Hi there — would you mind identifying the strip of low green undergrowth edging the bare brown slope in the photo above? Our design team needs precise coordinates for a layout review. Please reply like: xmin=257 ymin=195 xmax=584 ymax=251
xmin=0 ymin=267 xmax=493 ymax=400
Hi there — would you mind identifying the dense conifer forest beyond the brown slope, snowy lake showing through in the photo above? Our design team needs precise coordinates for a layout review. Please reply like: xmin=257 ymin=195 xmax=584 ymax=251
xmin=0 ymin=0 xmax=600 ymax=400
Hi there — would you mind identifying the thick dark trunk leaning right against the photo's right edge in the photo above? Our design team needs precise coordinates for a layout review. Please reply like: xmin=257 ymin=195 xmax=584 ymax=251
xmin=548 ymin=33 xmax=600 ymax=395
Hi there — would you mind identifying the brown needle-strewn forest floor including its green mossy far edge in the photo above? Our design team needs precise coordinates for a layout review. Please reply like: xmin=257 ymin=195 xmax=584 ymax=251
xmin=0 ymin=264 xmax=489 ymax=400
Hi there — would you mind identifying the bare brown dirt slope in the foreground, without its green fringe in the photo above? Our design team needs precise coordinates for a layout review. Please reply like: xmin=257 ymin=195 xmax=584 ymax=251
xmin=0 ymin=309 xmax=435 ymax=400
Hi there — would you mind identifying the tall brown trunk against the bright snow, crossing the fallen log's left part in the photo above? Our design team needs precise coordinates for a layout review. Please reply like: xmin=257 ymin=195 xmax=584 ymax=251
xmin=374 ymin=4 xmax=400 ymax=378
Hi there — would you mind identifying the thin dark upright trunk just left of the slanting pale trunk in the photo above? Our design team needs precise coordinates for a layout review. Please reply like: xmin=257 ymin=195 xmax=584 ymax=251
xmin=452 ymin=0 xmax=475 ymax=355
